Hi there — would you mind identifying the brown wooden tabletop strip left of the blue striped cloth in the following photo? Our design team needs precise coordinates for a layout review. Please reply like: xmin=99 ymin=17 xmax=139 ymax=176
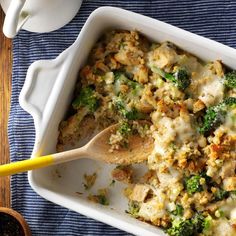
xmin=0 ymin=6 xmax=12 ymax=207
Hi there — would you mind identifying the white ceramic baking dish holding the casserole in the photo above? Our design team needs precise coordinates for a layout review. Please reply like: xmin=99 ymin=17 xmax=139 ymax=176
xmin=20 ymin=7 xmax=236 ymax=236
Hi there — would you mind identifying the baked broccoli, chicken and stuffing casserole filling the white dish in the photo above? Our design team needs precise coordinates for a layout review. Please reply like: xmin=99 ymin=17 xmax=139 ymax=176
xmin=57 ymin=30 xmax=236 ymax=236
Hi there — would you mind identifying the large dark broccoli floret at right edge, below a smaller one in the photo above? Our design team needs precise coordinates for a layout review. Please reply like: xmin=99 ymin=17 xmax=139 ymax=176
xmin=199 ymin=97 xmax=236 ymax=134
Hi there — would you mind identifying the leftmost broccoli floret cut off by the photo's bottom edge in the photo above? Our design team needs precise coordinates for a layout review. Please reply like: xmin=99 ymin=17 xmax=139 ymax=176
xmin=166 ymin=219 xmax=194 ymax=236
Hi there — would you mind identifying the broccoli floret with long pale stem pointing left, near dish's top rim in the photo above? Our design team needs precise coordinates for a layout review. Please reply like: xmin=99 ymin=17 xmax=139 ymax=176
xmin=151 ymin=66 xmax=191 ymax=90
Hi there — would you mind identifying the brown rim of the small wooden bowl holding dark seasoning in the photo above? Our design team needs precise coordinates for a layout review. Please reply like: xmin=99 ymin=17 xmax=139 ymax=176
xmin=0 ymin=207 xmax=32 ymax=236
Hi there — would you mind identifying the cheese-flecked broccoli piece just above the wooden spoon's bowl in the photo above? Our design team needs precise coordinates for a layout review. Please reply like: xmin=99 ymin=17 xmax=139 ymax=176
xmin=115 ymin=97 xmax=145 ymax=120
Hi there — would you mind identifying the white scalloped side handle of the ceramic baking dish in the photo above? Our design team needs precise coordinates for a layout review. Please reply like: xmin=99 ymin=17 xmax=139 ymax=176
xmin=19 ymin=45 xmax=74 ymax=138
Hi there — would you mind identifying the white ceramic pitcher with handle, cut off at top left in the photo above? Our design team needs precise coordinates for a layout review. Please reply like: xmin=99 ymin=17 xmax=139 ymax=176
xmin=0 ymin=0 xmax=82 ymax=38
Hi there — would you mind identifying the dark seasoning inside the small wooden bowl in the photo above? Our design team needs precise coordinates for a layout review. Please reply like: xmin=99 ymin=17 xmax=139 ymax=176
xmin=0 ymin=212 xmax=25 ymax=236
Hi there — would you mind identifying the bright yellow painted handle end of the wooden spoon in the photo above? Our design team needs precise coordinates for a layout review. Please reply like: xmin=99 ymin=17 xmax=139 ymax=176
xmin=0 ymin=155 xmax=54 ymax=176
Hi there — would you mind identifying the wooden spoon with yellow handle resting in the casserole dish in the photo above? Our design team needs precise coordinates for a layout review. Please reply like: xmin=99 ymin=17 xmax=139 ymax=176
xmin=0 ymin=124 xmax=154 ymax=176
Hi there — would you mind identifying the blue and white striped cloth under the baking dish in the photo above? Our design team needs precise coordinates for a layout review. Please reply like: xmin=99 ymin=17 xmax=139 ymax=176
xmin=9 ymin=0 xmax=236 ymax=236
